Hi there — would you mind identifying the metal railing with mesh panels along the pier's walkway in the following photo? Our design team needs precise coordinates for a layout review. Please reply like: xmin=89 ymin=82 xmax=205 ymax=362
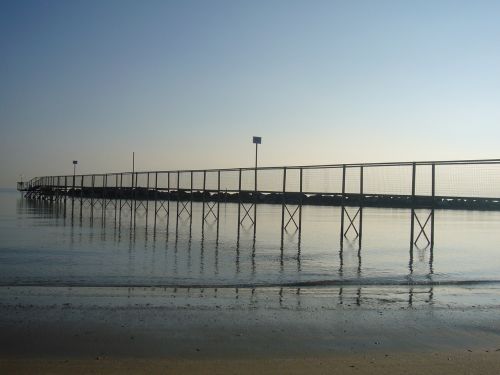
xmin=23 ymin=159 xmax=500 ymax=199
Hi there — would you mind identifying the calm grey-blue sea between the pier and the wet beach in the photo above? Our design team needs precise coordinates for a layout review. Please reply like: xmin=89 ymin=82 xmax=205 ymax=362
xmin=0 ymin=190 xmax=500 ymax=286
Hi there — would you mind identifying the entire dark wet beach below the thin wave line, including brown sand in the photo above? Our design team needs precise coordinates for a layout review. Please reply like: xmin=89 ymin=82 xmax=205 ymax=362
xmin=0 ymin=287 xmax=500 ymax=374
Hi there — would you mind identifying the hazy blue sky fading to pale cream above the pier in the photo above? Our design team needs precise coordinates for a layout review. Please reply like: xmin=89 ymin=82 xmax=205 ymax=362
xmin=0 ymin=0 xmax=500 ymax=187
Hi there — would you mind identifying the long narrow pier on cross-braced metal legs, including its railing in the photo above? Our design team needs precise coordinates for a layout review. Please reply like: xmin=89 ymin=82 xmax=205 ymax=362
xmin=18 ymin=159 xmax=500 ymax=253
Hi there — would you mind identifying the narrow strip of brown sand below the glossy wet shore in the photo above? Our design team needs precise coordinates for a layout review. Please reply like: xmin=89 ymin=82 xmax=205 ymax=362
xmin=0 ymin=352 xmax=500 ymax=375
